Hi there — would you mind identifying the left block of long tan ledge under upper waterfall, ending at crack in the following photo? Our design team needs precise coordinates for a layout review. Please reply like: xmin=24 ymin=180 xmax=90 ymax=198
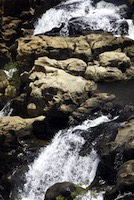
xmin=17 ymin=36 xmax=92 ymax=70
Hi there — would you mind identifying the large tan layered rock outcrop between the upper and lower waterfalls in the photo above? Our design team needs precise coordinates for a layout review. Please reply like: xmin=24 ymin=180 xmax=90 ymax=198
xmin=12 ymin=34 xmax=134 ymax=122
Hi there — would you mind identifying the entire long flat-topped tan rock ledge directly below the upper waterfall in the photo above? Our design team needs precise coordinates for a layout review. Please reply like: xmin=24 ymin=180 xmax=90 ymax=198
xmin=17 ymin=34 xmax=133 ymax=72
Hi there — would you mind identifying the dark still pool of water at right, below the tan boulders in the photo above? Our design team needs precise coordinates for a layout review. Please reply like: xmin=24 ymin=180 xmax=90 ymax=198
xmin=98 ymin=80 xmax=134 ymax=105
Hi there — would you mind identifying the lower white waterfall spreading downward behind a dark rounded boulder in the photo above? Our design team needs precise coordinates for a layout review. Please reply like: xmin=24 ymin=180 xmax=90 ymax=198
xmin=20 ymin=116 xmax=110 ymax=200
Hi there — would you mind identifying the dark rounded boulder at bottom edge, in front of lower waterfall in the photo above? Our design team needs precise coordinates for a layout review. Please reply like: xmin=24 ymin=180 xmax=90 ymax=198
xmin=44 ymin=182 xmax=86 ymax=200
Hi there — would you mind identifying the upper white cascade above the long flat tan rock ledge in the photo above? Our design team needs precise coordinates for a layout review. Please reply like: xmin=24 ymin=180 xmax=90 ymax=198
xmin=34 ymin=0 xmax=134 ymax=39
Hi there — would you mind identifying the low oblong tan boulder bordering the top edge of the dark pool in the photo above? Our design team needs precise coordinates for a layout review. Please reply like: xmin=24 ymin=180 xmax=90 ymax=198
xmin=85 ymin=65 xmax=123 ymax=82
